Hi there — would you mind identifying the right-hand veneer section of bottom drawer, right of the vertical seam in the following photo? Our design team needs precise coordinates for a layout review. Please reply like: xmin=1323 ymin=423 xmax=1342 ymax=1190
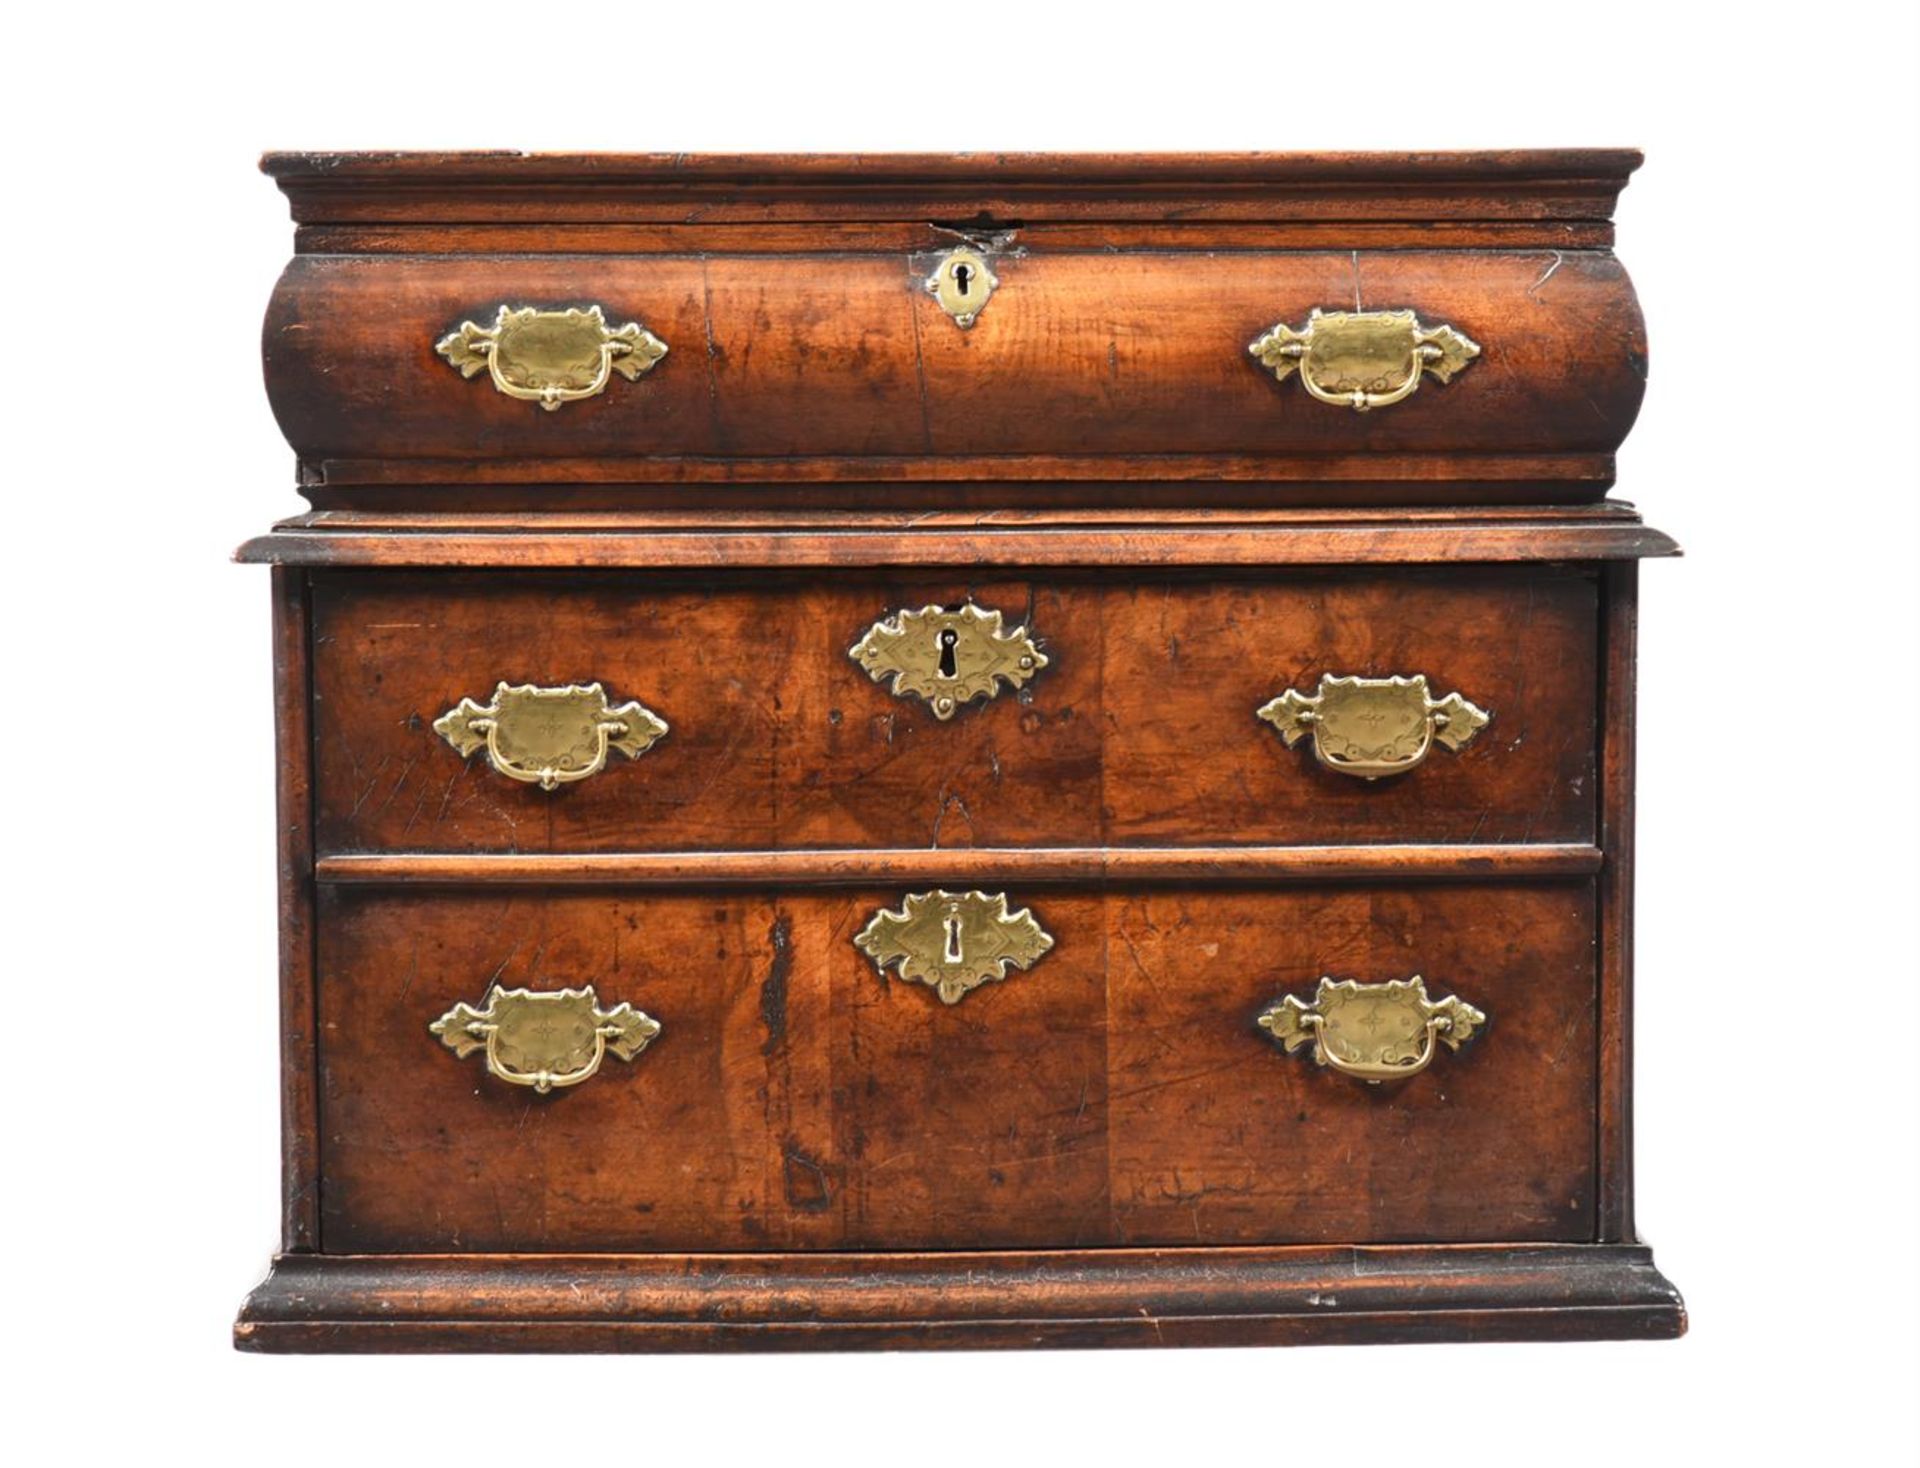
xmin=1108 ymin=883 xmax=1594 ymax=1243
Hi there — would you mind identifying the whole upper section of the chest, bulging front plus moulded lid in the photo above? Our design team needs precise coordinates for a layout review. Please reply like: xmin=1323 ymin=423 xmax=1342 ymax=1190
xmin=265 ymin=150 xmax=1645 ymax=503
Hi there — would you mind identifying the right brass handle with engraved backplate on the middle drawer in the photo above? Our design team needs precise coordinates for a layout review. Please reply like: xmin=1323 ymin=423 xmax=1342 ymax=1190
xmin=1258 ymin=674 xmax=1492 ymax=779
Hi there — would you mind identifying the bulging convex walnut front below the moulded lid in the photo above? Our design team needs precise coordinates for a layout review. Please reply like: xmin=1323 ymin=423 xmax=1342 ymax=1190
xmin=265 ymin=248 xmax=1645 ymax=478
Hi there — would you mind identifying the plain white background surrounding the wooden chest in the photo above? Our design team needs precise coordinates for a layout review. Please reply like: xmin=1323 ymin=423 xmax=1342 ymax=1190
xmin=0 ymin=0 xmax=1920 ymax=1466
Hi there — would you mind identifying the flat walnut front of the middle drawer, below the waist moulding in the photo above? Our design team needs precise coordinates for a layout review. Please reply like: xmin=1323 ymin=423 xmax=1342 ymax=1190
xmin=313 ymin=568 xmax=1597 ymax=852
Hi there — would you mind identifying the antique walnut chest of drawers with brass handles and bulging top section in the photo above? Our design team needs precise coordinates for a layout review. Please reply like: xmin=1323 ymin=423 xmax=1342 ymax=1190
xmin=236 ymin=152 xmax=1684 ymax=1351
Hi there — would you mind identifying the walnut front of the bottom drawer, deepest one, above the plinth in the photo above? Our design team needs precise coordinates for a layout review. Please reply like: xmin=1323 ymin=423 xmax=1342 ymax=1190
xmin=319 ymin=881 xmax=1596 ymax=1253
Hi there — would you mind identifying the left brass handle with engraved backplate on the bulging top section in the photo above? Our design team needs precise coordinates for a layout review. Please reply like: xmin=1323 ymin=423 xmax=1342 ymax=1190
xmin=434 ymin=305 xmax=666 ymax=413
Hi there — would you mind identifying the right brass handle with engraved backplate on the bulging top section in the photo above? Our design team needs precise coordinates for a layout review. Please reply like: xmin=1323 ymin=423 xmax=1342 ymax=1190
xmin=1248 ymin=307 xmax=1480 ymax=413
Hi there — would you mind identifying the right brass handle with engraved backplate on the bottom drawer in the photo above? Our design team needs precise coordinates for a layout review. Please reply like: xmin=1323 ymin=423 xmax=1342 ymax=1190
xmin=1258 ymin=975 xmax=1486 ymax=1082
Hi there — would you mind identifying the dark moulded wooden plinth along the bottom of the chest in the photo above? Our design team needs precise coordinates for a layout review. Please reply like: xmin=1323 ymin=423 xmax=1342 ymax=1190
xmin=234 ymin=1243 xmax=1686 ymax=1351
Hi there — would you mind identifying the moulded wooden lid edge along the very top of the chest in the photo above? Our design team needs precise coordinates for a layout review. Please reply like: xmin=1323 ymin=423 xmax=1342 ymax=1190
xmin=261 ymin=148 xmax=1640 ymax=233
